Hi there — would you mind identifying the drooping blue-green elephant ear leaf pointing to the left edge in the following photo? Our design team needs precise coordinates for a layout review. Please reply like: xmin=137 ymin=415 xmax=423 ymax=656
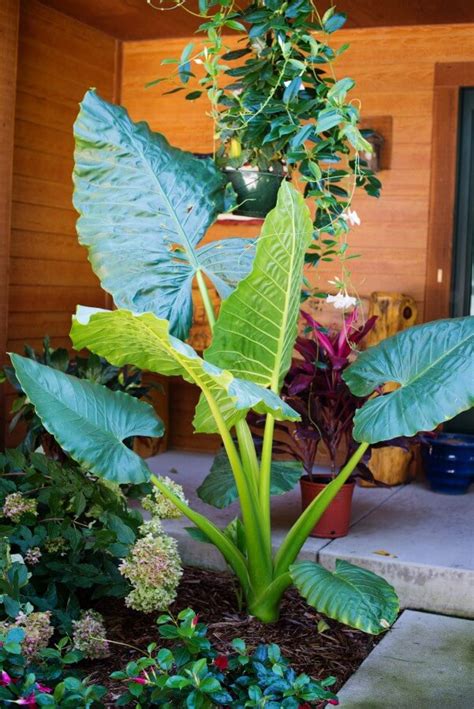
xmin=10 ymin=354 xmax=164 ymax=483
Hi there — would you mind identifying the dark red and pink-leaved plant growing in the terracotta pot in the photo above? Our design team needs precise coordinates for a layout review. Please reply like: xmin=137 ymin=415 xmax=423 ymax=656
xmin=275 ymin=309 xmax=377 ymax=480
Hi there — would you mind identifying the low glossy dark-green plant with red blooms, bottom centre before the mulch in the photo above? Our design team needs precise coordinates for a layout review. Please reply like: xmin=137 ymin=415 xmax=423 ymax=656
xmin=112 ymin=608 xmax=335 ymax=709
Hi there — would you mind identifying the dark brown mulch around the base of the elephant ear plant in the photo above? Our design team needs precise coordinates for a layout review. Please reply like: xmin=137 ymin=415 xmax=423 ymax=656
xmin=84 ymin=568 xmax=380 ymax=707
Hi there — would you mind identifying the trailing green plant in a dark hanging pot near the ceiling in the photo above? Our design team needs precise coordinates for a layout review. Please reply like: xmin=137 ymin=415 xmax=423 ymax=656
xmin=150 ymin=0 xmax=380 ymax=238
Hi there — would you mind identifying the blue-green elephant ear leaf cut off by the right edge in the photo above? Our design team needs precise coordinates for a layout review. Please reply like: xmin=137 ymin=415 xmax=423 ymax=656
xmin=343 ymin=317 xmax=474 ymax=443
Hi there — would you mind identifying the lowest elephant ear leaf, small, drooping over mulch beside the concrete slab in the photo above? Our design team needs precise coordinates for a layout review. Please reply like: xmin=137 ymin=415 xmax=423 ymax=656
xmin=290 ymin=559 xmax=400 ymax=635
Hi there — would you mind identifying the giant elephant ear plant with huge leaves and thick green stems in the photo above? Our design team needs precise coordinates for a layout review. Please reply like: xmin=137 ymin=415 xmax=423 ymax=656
xmin=8 ymin=94 xmax=474 ymax=633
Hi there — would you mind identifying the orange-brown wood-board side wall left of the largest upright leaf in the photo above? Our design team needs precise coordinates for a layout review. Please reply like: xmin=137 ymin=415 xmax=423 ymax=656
xmin=8 ymin=0 xmax=116 ymax=360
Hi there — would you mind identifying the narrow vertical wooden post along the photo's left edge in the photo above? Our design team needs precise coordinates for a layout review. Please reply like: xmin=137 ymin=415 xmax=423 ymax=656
xmin=0 ymin=0 xmax=20 ymax=444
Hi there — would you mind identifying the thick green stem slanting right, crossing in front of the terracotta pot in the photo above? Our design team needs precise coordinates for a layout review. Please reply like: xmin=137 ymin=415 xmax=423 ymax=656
xmin=275 ymin=443 xmax=369 ymax=576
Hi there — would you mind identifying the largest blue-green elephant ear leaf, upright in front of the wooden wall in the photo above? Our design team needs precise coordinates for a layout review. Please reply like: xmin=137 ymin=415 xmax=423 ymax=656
xmin=74 ymin=91 xmax=254 ymax=339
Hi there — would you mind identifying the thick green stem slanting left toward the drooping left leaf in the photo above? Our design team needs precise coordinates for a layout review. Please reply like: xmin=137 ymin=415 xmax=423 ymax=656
xmin=151 ymin=475 xmax=250 ymax=593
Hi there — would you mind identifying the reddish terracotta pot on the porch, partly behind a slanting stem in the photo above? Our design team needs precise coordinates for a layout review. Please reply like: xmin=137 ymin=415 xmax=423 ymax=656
xmin=300 ymin=476 xmax=354 ymax=539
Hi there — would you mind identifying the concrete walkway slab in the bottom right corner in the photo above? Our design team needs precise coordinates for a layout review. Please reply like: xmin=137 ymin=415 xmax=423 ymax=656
xmin=338 ymin=611 xmax=474 ymax=709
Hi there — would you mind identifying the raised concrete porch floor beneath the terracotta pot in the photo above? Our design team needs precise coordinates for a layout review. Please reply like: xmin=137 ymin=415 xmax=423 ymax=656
xmin=149 ymin=451 xmax=474 ymax=616
